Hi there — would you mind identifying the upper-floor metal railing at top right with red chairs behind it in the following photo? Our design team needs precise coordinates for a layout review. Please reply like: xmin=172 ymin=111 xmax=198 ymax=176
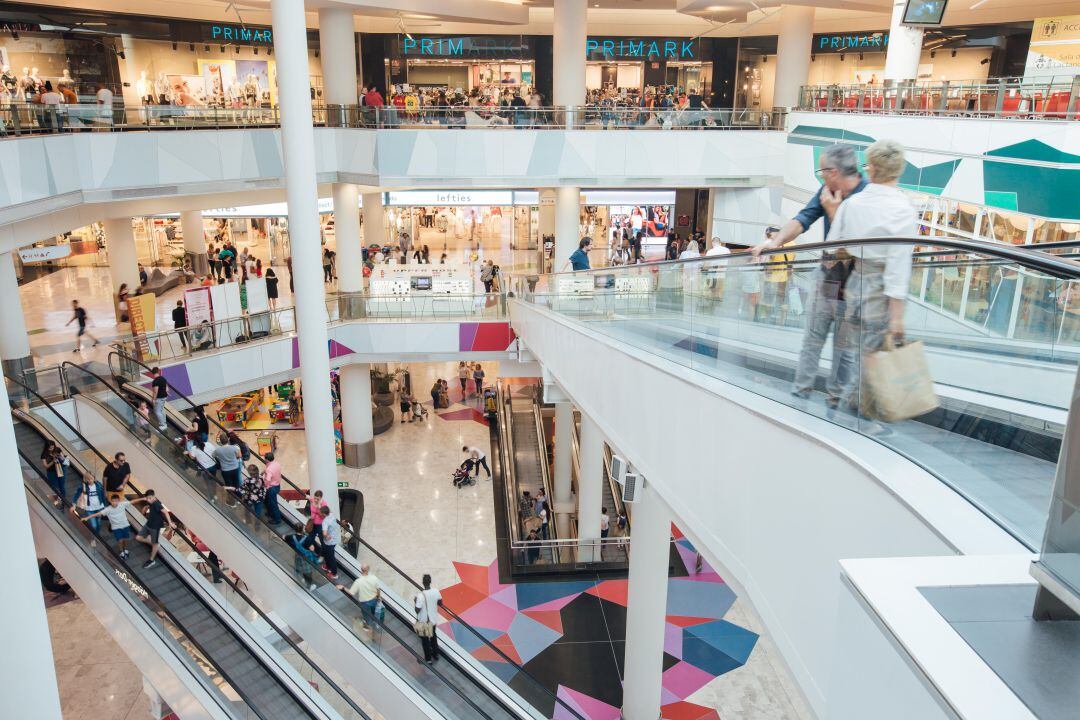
xmin=798 ymin=76 xmax=1080 ymax=120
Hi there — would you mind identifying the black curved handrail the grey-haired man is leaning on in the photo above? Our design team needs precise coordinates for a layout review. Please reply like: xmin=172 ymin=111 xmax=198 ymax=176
xmin=527 ymin=236 xmax=1080 ymax=280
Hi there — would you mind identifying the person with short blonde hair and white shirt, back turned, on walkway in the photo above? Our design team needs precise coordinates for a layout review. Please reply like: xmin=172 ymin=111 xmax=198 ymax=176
xmin=826 ymin=140 xmax=918 ymax=414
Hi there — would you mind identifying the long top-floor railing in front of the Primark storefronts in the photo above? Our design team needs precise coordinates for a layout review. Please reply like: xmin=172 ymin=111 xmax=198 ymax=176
xmin=0 ymin=103 xmax=784 ymax=138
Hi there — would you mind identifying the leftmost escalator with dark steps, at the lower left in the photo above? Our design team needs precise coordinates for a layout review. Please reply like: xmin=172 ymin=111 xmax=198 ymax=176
xmin=12 ymin=390 xmax=356 ymax=720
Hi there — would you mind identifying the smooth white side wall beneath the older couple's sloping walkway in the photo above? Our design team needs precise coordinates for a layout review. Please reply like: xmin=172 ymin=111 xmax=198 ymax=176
xmin=511 ymin=301 xmax=1021 ymax=717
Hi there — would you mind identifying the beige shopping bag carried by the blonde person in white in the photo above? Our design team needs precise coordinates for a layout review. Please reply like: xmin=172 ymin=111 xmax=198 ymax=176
xmin=860 ymin=335 xmax=941 ymax=422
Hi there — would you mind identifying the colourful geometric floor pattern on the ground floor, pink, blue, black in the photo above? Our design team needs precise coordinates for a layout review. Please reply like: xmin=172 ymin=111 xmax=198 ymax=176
xmin=442 ymin=526 xmax=757 ymax=720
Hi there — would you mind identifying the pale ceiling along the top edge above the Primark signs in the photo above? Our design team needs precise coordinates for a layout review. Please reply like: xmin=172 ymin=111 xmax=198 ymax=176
xmin=6 ymin=0 xmax=1080 ymax=37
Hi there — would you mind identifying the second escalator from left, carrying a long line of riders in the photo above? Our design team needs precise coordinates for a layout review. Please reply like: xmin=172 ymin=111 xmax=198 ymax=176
xmin=64 ymin=364 xmax=580 ymax=719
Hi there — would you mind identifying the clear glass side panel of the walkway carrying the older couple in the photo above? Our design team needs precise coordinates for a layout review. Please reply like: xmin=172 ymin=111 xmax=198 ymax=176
xmin=512 ymin=244 xmax=1080 ymax=547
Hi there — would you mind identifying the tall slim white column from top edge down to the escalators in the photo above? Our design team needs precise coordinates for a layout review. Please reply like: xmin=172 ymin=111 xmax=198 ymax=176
xmin=271 ymin=0 xmax=338 ymax=515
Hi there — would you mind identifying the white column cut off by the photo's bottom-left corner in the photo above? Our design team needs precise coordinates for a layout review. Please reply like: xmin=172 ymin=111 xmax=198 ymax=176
xmin=0 ymin=383 xmax=60 ymax=720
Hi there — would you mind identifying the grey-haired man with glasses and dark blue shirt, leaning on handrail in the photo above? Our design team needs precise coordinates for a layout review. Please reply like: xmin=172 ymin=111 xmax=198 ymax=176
xmin=751 ymin=145 xmax=866 ymax=407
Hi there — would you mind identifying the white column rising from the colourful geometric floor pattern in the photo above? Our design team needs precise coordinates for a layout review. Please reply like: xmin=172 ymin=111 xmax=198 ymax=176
xmin=622 ymin=483 xmax=669 ymax=720
